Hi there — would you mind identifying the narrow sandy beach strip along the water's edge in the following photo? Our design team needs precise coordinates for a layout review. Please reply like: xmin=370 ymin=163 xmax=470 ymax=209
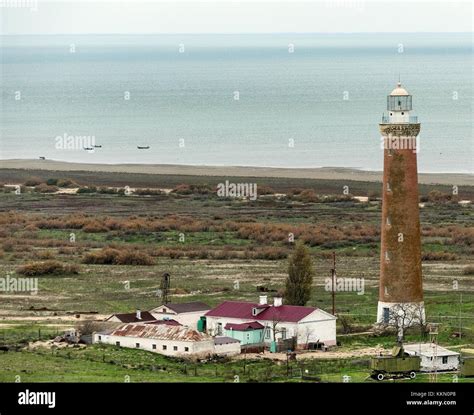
xmin=0 ymin=159 xmax=474 ymax=186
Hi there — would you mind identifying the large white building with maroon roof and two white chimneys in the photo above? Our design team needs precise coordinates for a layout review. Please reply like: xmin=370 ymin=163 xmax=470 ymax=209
xmin=206 ymin=295 xmax=336 ymax=349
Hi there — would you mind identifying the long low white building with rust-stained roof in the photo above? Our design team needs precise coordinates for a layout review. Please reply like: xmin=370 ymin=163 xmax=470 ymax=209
xmin=93 ymin=323 xmax=215 ymax=357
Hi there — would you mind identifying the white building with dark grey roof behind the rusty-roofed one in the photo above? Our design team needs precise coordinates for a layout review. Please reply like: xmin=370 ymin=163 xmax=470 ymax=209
xmin=150 ymin=301 xmax=211 ymax=329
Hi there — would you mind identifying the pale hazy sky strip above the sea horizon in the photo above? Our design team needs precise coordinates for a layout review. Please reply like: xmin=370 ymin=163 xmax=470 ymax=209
xmin=0 ymin=0 xmax=473 ymax=34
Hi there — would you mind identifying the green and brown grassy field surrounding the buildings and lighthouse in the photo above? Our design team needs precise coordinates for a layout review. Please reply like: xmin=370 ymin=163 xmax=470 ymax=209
xmin=0 ymin=171 xmax=474 ymax=382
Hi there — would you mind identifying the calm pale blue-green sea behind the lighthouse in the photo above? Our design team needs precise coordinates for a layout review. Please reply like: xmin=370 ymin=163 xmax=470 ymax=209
xmin=0 ymin=33 xmax=474 ymax=173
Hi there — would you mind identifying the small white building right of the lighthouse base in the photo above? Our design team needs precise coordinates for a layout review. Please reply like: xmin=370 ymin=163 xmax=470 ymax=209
xmin=403 ymin=343 xmax=460 ymax=372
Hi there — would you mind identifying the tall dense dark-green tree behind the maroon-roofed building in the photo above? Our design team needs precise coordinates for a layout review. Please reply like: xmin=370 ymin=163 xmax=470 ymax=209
xmin=285 ymin=243 xmax=313 ymax=305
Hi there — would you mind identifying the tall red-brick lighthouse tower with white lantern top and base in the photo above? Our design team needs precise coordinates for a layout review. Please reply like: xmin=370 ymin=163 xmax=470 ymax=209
xmin=377 ymin=83 xmax=425 ymax=326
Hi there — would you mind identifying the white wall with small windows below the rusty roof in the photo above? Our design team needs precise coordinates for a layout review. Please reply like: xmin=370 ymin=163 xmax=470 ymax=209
xmin=92 ymin=333 xmax=214 ymax=356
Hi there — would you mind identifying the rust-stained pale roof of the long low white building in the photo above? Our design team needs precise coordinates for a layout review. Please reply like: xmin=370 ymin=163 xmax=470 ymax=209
xmin=110 ymin=324 xmax=212 ymax=342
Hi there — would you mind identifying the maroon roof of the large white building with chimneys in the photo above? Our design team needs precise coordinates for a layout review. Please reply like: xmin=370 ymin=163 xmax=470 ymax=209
xmin=206 ymin=301 xmax=317 ymax=323
